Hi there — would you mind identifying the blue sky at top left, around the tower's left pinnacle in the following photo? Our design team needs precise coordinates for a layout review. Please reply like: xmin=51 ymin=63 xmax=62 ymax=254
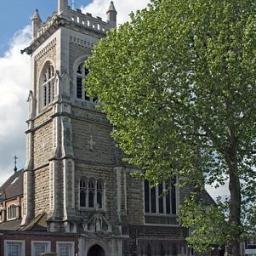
xmin=0 ymin=0 xmax=90 ymax=56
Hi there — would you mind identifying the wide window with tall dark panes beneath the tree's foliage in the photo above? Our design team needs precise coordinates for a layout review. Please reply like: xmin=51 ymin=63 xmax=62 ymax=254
xmin=144 ymin=179 xmax=176 ymax=215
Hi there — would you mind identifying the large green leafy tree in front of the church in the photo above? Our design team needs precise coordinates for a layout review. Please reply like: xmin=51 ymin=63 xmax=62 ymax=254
xmin=86 ymin=0 xmax=256 ymax=255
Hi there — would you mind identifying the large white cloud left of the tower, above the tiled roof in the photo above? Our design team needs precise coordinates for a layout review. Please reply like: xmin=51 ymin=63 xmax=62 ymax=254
xmin=0 ymin=26 xmax=31 ymax=184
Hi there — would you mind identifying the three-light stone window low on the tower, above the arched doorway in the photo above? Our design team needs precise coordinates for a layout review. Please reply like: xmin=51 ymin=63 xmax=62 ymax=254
xmin=80 ymin=178 xmax=104 ymax=209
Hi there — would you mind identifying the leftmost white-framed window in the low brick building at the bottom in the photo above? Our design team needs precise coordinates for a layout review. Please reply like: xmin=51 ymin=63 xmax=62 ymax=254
xmin=4 ymin=240 xmax=25 ymax=256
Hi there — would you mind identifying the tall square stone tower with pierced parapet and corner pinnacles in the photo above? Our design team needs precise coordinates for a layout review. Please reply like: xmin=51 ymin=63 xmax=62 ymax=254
xmin=22 ymin=0 xmax=118 ymax=232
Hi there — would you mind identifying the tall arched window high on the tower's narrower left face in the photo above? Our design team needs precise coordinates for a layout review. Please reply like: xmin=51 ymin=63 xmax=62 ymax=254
xmin=40 ymin=62 xmax=55 ymax=107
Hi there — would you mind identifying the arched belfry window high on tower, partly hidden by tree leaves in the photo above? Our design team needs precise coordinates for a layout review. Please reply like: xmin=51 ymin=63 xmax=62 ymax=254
xmin=76 ymin=63 xmax=97 ymax=102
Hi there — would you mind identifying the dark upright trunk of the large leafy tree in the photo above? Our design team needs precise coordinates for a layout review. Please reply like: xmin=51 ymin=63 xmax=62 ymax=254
xmin=227 ymin=135 xmax=241 ymax=256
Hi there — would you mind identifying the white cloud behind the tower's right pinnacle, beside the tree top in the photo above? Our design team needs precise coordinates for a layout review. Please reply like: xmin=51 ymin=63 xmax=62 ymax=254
xmin=82 ymin=0 xmax=150 ymax=24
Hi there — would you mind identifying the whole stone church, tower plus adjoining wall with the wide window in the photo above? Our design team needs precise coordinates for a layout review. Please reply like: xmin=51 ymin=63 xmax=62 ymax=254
xmin=22 ymin=0 xmax=189 ymax=256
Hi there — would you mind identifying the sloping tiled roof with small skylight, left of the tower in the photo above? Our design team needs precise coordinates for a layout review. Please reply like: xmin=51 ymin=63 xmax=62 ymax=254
xmin=0 ymin=170 xmax=23 ymax=201
